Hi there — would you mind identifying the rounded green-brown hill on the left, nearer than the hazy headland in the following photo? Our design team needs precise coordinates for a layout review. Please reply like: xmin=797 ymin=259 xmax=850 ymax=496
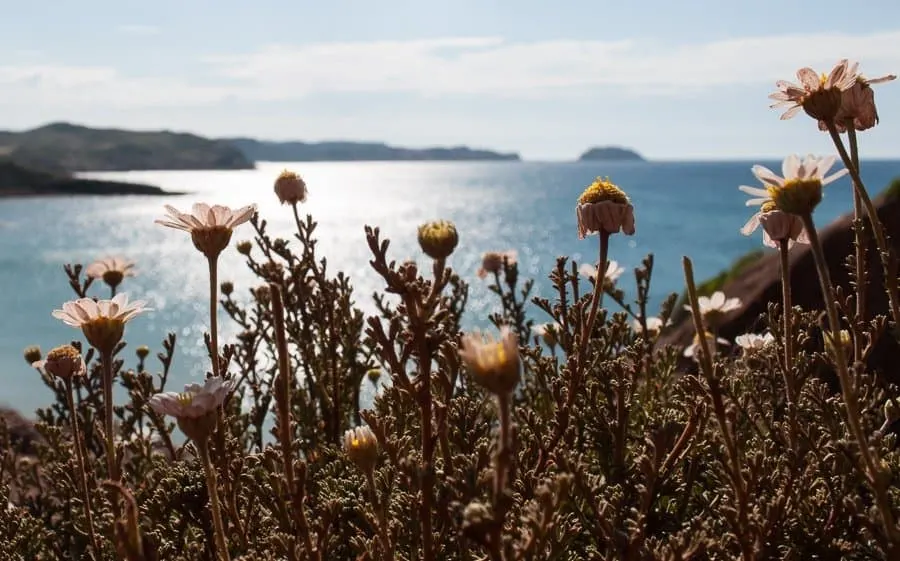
xmin=0 ymin=123 xmax=253 ymax=173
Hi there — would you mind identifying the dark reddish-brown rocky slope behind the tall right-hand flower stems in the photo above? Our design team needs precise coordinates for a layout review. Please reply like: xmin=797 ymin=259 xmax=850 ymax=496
xmin=660 ymin=188 xmax=900 ymax=383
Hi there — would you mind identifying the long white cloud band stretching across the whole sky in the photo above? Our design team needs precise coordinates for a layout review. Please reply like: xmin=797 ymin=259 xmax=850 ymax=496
xmin=0 ymin=30 xmax=900 ymax=107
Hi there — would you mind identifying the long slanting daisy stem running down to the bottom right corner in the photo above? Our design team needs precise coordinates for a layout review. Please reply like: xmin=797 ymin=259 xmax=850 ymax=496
xmin=801 ymin=210 xmax=898 ymax=543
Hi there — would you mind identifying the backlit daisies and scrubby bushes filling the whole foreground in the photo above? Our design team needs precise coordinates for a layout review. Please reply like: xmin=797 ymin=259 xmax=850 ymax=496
xmin=0 ymin=61 xmax=900 ymax=561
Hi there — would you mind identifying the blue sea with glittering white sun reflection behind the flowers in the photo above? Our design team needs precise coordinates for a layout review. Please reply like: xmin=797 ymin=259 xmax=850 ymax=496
xmin=0 ymin=161 xmax=900 ymax=411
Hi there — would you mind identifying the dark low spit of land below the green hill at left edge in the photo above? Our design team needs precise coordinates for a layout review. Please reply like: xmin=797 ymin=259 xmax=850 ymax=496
xmin=0 ymin=159 xmax=179 ymax=198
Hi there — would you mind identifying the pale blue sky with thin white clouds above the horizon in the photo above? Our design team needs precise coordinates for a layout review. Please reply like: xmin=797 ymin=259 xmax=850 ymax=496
xmin=0 ymin=0 xmax=900 ymax=160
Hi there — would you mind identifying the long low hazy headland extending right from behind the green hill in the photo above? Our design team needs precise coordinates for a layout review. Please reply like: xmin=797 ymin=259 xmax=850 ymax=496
xmin=223 ymin=138 xmax=521 ymax=162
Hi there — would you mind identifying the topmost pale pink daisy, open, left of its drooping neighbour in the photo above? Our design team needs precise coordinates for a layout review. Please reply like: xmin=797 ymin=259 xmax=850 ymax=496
xmin=769 ymin=59 xmax=859 ymax=121
